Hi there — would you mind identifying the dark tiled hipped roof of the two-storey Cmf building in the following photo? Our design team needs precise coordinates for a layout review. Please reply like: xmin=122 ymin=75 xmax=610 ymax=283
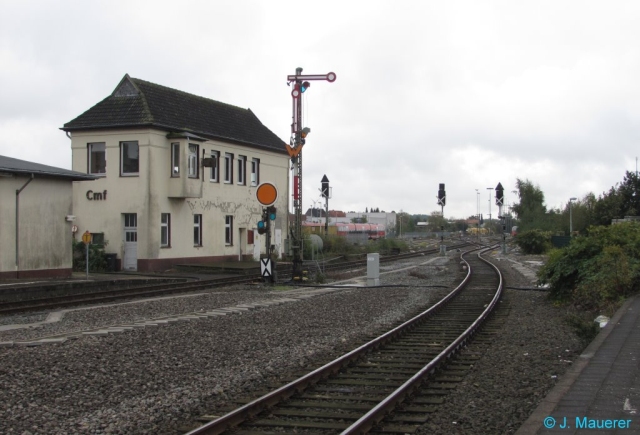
xmin=62 ymin=74 xmax=286 ymax=153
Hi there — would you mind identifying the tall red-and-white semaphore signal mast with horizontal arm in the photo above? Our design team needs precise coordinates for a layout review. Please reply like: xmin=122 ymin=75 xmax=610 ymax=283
xmin=286 ymin=68 xmax=336 ymax=279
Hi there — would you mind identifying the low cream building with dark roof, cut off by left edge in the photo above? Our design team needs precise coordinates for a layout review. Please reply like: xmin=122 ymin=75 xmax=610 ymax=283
xmin=0 ymin=156 xmax=95 ymax=279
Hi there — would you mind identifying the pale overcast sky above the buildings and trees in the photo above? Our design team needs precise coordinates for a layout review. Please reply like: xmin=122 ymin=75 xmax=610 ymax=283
xmin=0 ymin=0 xmax=640 ymax=218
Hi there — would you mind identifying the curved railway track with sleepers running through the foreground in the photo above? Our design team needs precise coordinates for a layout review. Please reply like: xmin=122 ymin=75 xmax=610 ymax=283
xmin=182 ymin=247 xmax=502 ymax=435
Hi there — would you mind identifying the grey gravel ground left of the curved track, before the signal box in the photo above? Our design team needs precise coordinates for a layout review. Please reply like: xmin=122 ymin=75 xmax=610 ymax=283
xmin=0 ymin=254 xmax=460 ymax=435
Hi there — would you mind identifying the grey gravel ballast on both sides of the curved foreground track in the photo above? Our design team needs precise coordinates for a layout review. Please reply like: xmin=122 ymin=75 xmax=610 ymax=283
xmin=0 ymin=253 xmax=582 ymax=435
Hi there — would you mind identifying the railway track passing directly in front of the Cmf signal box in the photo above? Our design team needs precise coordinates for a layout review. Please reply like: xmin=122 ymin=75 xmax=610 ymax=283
xmin=0 ymin=242 xmax=468 ymax=315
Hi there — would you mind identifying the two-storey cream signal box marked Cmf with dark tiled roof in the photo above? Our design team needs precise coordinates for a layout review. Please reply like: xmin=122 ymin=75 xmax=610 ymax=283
xmin=62 ymin=75 xmax=289 ymax=271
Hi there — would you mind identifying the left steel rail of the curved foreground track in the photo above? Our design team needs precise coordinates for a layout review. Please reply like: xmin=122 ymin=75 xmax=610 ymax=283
xmin=185 ymin=248 xmax=484 ymax=435
